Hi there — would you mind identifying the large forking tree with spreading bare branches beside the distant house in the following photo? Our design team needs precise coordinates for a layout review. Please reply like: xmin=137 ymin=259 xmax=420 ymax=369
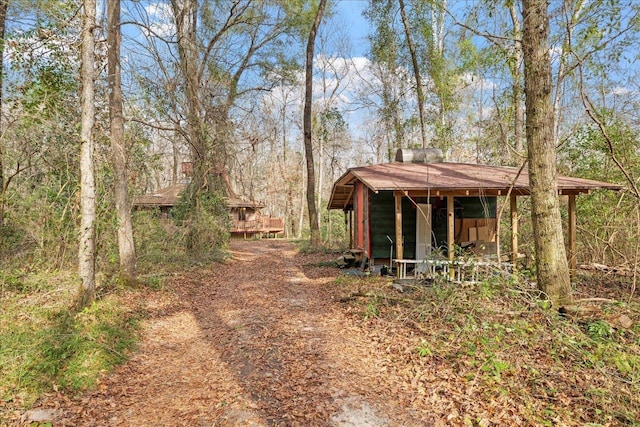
xmin=160 ymin=0 xmax=294 ymax=199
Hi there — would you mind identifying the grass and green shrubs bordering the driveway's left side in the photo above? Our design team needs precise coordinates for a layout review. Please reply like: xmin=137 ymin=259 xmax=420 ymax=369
xmin=0 ymin=211 xmax=234 ymax=425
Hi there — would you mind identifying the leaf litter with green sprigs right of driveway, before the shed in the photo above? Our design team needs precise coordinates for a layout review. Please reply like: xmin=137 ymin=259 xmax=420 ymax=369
xmin=336 ymin=276 xmax=640 ymax=426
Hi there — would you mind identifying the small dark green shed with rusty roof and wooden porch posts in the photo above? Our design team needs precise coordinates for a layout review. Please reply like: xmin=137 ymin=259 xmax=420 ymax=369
xmin=328 ymin=150 xmax=622 ymax=280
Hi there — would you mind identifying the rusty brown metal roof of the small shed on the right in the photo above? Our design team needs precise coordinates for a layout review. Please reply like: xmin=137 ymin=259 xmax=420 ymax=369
xmin=328 ymin=162 xmax=622 ymax=209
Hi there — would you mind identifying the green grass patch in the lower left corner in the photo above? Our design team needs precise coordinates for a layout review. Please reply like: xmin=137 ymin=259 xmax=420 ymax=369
xmin=0 ymin=273 xmax=144 ymax=407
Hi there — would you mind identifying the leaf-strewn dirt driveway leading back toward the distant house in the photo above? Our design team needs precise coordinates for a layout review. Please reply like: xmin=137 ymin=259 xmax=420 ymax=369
xmin=38 ymin=241 xmax=430 ymax=426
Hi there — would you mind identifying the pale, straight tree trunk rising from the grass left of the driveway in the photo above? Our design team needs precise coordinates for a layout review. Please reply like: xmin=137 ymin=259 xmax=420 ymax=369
xmin=77 ymin=0 xmax=96 ymax=307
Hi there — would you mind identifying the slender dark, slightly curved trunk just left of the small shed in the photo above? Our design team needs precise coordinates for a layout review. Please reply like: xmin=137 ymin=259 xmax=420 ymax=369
xmin=303 ymin=0 xmax=327 ymax=247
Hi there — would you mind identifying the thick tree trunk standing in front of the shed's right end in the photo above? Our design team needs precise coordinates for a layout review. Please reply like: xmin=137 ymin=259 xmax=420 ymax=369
xmin=522 ymin=0 xmax=572 ymax=305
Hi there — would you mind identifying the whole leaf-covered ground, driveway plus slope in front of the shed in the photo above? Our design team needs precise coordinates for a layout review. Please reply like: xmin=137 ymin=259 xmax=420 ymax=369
xmin=6 ymin=240 xmax=640 ymax=426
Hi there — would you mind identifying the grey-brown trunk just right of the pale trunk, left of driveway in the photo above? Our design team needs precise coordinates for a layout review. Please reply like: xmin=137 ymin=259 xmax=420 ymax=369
xmin=107 ymin=0 xmax=136 ymax=280
